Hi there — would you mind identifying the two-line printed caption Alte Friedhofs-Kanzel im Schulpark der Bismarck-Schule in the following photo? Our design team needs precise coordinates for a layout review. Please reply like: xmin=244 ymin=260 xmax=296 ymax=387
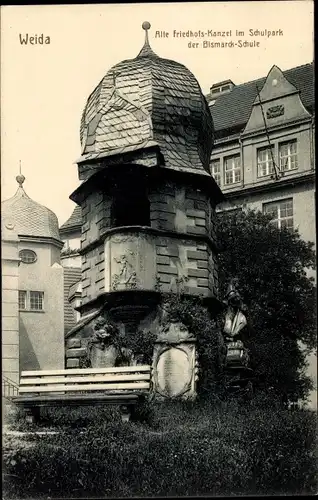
xmin=155 ymin=28 xmax=284 ymax=49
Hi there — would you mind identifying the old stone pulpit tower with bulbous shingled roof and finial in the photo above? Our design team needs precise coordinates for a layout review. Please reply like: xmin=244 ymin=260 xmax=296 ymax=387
xmin=68 ymin=22 xmax=223 ymax=398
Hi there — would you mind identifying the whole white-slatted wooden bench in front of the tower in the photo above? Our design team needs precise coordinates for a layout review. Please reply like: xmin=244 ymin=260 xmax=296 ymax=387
xmin=11 ymin=365 xmax=150 ymax=422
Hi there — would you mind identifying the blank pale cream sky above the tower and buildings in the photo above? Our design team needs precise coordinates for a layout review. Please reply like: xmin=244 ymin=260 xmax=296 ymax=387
xmin=1 ymin=0 xmax=314 ymax=224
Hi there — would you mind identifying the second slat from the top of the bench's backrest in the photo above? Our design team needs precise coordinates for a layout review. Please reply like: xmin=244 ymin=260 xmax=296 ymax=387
xmin=20 ymin=373 xmax=150 ymax=386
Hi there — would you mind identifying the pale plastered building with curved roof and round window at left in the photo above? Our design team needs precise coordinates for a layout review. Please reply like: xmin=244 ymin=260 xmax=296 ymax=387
xmin=1 ymin=175 xmax=64 ymax=382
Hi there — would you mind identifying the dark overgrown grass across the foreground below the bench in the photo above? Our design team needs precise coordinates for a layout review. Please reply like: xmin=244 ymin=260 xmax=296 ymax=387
xmin=3 ymin=401 xmax=317 ymax=499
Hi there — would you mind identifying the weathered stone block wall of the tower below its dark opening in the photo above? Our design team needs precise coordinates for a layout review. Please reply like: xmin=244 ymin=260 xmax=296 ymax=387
xmin=81 ymin=180 xmax=218 ymax=305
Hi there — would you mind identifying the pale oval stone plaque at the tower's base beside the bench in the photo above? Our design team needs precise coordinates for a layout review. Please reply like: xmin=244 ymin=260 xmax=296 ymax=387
xmin=156 ymin=347 xmax=192 ymax=397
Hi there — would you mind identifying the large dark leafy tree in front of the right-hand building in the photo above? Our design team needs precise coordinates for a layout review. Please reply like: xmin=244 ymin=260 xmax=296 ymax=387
xmin=218 ymin=210 xmax=316 ymax=400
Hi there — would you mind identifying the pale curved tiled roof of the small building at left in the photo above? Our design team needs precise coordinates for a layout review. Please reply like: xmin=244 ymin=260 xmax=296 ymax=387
xmin=1 ymin=186 xmax=60 ymax=240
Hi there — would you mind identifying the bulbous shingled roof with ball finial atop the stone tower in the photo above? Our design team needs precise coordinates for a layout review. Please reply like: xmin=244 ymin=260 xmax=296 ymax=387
xmin=78 ymin=23 xmax=213 ymax=177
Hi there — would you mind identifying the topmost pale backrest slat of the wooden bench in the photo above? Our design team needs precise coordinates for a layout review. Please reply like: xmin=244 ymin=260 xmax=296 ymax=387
xmin=21 ymin=365 xmax=151 ymax=377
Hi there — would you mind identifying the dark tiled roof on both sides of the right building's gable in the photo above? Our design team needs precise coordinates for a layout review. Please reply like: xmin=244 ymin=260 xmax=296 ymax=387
xmin=210 ymin=63 xmax=314 ymax=138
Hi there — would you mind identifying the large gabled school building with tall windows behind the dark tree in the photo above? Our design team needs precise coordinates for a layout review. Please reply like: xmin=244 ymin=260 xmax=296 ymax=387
xmin=207 ymin=64 xmax=316 ymax=248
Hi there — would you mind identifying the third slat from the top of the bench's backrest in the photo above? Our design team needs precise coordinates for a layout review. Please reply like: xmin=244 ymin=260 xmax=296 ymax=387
xmin=19 ymin=382 xmax=150 ymax=394
